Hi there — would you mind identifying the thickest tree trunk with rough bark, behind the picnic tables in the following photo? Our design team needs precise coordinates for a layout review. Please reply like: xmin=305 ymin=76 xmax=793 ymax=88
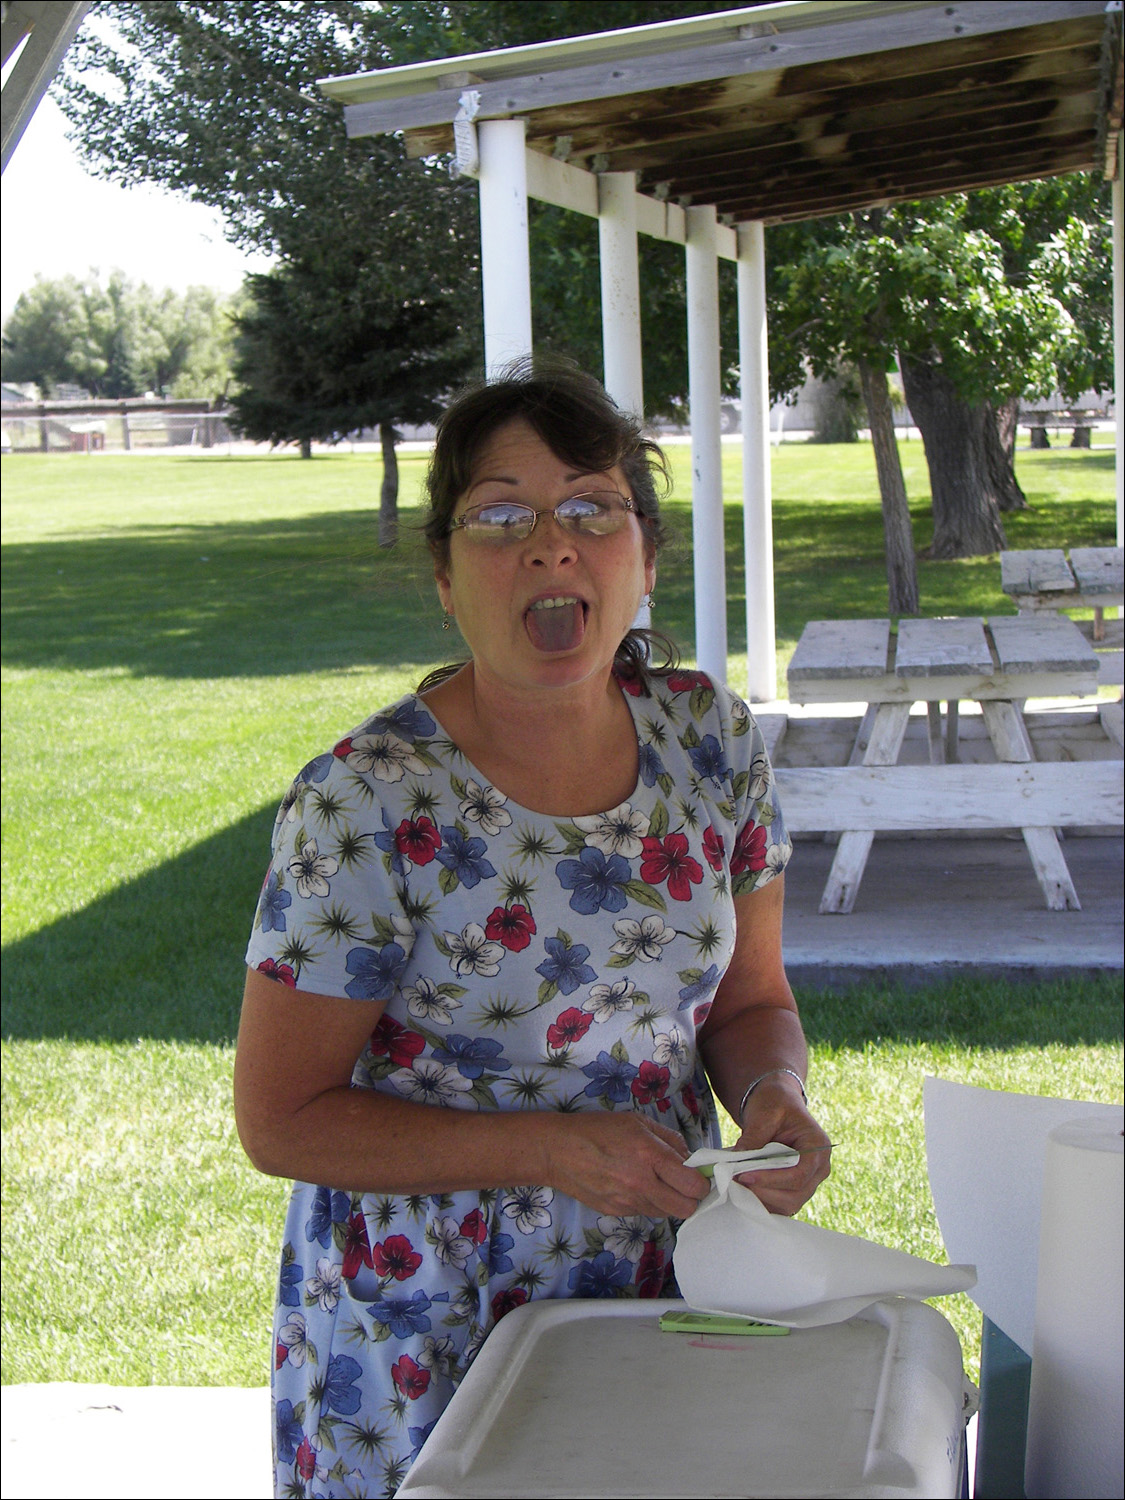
xmin=899 ymin=354 xmax=1008 ymax=558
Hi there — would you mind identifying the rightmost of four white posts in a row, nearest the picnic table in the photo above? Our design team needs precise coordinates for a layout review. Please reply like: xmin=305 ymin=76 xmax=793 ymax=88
xmin=738 ymin=224 xmax=777 ymax=704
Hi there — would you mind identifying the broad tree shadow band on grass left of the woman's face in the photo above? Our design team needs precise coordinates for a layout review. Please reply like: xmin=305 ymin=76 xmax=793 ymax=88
xmin=3 ymin=510 xmax=447 ymax=678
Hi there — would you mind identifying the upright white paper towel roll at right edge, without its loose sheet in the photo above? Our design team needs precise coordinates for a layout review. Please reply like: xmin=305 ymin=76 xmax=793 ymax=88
xmin=1025 ymin=1119 xmax=1125 ymax=1500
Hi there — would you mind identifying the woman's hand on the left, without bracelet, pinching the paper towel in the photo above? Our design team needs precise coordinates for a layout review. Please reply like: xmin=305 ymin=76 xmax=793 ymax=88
xmin=540 ymin=1110 xmax=711 ymax=1220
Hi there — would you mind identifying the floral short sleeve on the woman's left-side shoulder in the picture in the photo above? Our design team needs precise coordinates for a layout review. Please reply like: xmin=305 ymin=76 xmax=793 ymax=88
xmin=246 ymin=755 xmax=414 ymax=1002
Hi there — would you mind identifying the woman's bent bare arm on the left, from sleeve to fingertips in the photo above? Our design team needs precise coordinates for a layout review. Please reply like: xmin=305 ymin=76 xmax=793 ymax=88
xmin=234 ymin=969 xmax=707 ymax=1218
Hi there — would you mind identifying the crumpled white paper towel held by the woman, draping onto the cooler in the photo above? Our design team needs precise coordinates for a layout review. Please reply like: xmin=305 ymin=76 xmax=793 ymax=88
xmin=674 ymin=1152 xmax=975 ymax=1328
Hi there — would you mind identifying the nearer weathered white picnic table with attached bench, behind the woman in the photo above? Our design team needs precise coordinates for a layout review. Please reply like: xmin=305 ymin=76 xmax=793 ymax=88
xmin=777 ymin=615 xmax=1122 ymax=912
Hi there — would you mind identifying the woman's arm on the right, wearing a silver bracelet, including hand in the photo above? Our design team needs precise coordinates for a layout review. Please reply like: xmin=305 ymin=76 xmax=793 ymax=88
xmin=699 ymin=876 xmax=831 ymax=1214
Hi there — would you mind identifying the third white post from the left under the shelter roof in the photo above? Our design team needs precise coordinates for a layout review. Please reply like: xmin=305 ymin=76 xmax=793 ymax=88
xmin=686 ymin=204 xmax=726 ymax=681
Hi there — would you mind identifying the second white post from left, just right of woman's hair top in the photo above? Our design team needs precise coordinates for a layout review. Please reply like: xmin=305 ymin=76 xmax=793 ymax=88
xmin=597 ymin=173 xmax=645 ymax=417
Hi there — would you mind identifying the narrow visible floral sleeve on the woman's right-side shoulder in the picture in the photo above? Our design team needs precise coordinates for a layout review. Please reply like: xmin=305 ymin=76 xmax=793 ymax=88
xmin=713 ymin=683 xmax=794 ymax=896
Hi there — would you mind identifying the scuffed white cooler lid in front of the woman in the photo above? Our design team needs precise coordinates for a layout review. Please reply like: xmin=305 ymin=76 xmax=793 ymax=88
xmin=398 ymin=1298 xmax=965 ymax=1500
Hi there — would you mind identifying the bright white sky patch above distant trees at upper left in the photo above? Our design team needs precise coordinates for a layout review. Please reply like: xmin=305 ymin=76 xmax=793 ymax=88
xmin=0 ymin=93 xmax=269 ymax=320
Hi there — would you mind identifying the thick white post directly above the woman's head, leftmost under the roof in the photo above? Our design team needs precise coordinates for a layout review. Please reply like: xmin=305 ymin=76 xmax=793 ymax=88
xmin=477 ymin=120 xmax=531 ymax=378
